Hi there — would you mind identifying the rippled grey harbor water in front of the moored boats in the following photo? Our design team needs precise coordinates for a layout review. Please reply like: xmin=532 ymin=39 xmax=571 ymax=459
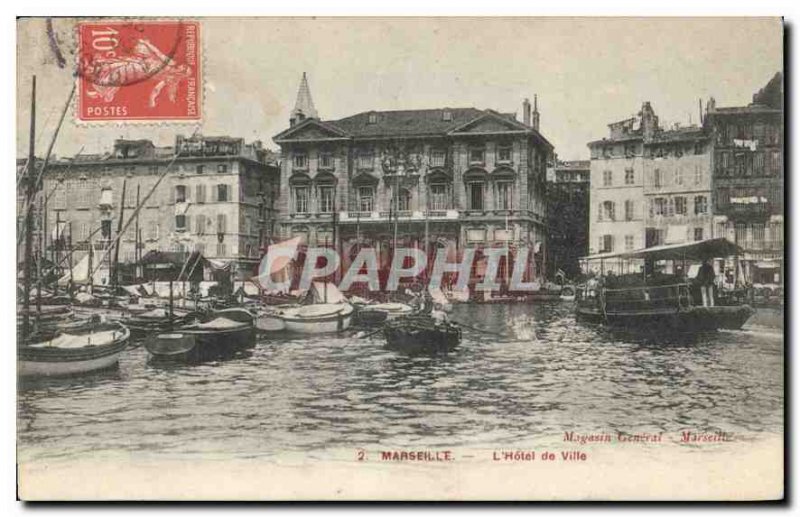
xmin=18 ymin=303 xmax=784 ymax=462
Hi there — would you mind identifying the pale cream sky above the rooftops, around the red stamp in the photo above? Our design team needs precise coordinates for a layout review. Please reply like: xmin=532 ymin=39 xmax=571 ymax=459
xmin=17 ymin=18 xmax=783 ymax=160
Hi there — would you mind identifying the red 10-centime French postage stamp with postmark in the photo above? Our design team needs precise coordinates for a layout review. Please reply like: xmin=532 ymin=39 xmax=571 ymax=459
xmin=77 ymin=20 xmax=202 ymax=121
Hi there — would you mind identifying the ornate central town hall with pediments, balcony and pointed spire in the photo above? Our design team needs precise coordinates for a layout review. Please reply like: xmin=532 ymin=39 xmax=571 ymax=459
xmin=274 ymin=76 xmax=553 ymax=290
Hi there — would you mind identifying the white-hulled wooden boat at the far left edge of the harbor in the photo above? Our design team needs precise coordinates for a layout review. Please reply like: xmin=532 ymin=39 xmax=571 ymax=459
xmin=17 ymin=323 xmax=130 ymax=376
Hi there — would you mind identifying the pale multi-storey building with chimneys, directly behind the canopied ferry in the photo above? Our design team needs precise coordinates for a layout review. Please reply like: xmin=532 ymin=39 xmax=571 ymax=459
xmin=589 ymin=102 xmax=712 ymax=270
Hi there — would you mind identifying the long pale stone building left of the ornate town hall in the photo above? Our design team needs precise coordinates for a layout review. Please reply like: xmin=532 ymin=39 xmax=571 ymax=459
xmin=43 ymin=136 xmax=279 ymax=282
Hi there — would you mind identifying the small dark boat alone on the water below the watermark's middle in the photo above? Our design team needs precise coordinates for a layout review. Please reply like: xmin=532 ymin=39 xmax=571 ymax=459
xmin=383 ymin=315 xmax=461 ymax=354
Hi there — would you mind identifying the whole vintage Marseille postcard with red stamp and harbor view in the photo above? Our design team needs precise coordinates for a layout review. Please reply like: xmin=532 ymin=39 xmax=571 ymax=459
xmin=16 ymin=16 xmax=786 ymax=501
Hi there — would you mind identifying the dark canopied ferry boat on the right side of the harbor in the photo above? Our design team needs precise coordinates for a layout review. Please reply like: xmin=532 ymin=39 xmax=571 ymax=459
xmin=576 ymin=239 xmax=754 ymax=332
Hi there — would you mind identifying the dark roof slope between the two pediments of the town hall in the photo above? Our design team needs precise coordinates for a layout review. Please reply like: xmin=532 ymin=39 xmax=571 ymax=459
xmin=327 ymin=108 xmax=484 ymax=137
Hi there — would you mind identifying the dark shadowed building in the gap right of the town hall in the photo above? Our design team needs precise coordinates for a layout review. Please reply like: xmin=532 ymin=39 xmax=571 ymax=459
xmin=547 ymin=160 xmax=590 ymax=278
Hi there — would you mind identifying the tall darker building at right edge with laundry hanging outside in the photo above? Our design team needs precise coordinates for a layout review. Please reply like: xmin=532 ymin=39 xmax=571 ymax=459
xmin=704 ymin=73 xmax=784 ymax=284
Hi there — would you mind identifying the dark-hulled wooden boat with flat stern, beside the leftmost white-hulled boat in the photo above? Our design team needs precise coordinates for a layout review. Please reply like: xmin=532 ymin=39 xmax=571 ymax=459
xmin=145 ymin=309 xmax=256 ymax=363
